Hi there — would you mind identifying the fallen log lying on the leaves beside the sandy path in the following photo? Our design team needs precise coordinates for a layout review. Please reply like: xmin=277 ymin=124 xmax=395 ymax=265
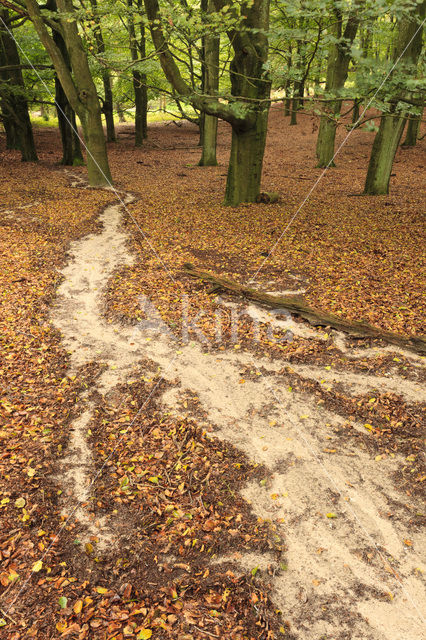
xmin=183 ymin=262 xmax=426 ymax=355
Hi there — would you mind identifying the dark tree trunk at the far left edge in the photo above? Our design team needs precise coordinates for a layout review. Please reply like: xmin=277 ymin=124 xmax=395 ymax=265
xmin=0 ymin=9 xmax=37 ymax=162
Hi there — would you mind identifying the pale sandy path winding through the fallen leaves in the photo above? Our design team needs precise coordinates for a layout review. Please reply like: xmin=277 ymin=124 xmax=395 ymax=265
xmin=51 ymin=184 xmax=426 ymax=640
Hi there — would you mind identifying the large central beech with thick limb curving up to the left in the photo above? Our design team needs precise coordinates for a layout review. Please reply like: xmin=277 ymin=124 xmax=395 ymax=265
xmin=145 ymin=0 xmax=271 ymax=205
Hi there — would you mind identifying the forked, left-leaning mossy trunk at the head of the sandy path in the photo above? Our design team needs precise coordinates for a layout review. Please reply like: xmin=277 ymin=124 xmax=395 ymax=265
xmin=25 ymin=0 xmax=112 ymax=187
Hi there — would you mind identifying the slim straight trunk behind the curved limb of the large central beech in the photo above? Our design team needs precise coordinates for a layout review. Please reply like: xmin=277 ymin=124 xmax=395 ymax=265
xmin=198 ymin=0 xmax=220 ymax=167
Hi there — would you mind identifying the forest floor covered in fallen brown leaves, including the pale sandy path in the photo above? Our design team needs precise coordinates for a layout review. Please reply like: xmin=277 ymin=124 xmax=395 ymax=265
xmin=0 ymin=107 xmax=426 ymax=640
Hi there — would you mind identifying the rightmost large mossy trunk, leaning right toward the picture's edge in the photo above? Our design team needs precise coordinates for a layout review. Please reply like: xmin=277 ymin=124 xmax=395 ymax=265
xmin=364 ymin=1 xmax=426 ymax=195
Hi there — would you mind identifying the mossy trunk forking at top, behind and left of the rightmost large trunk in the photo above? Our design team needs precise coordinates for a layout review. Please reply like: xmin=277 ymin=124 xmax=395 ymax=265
xmin=316 ymin=0 xmax=361 ymax=167
